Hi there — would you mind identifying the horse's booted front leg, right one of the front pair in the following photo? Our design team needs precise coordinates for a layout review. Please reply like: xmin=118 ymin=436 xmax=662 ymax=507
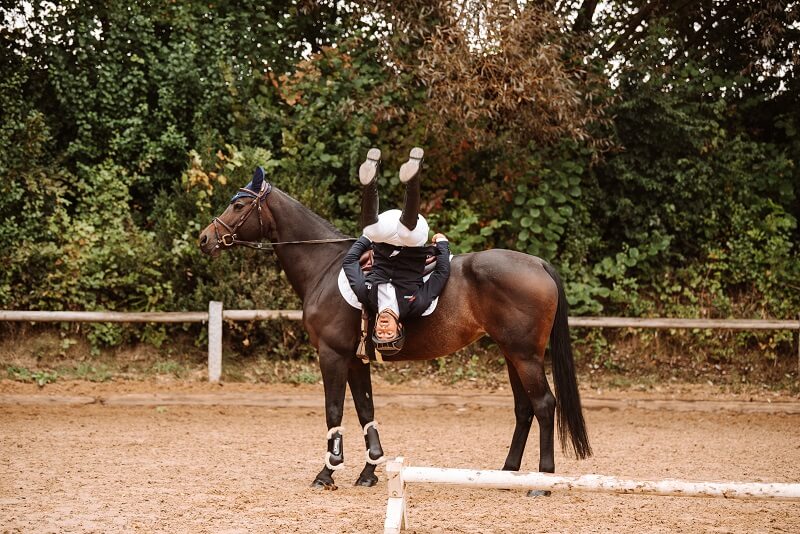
xmin=347 ymin=358 xmax=386 ymax=487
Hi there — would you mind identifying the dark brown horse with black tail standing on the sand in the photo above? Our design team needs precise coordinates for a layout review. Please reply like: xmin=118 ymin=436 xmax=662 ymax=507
xmin=199 ymin=168 xmax=591 ymax=487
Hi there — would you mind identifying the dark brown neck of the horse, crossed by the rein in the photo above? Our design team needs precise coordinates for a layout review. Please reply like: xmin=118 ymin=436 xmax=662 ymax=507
xmin=267 ymin=189 xmax=347 ymax=301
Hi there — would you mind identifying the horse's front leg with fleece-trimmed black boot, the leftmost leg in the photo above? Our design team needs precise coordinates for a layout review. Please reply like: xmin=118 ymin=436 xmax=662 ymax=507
xmin=311 ymin=344 xmax=352 ymax=489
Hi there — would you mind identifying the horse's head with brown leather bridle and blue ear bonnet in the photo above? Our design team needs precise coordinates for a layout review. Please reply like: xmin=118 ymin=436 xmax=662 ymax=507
xmin=199 ymin=167 xmax=275 ymax=256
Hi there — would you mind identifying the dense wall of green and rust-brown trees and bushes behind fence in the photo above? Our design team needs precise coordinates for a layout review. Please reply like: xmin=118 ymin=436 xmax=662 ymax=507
xmin=0 ymin=0 xmax=800 ymax=366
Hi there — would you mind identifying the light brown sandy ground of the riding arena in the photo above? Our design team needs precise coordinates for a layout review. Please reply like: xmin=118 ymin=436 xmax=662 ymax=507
xmin=0 ymin=385 xmax=800 ymax=533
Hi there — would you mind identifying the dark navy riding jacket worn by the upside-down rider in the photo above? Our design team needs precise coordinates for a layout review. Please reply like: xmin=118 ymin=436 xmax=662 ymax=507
xmin=342 ymin=236 xmax=450 ymax=320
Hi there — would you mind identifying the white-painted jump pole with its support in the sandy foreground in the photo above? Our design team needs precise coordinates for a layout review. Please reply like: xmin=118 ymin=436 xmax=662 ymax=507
xmin=384 ymin=456 xmax=800 ymax=534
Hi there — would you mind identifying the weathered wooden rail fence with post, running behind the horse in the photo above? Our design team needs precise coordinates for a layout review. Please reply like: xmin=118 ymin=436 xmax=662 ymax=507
xmin=0 ymin=301 xmax=800 ymax=382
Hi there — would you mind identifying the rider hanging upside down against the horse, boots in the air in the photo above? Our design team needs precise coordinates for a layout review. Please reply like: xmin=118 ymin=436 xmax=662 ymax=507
xmin=342 ymin=148 xmax=450 ymax=356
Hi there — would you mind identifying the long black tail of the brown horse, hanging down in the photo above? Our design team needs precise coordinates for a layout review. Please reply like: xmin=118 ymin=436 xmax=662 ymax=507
xmin=543 ymin=263 xmax=592 ymax=459
